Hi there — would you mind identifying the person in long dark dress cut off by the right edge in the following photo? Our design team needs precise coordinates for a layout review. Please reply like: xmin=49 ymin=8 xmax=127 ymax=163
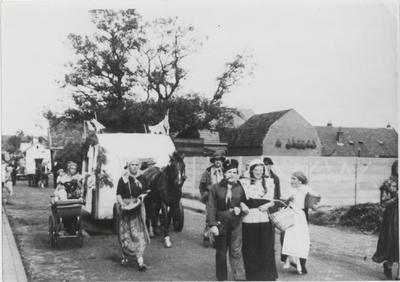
xmin=372 ymin=160 xmax=400 ymax=280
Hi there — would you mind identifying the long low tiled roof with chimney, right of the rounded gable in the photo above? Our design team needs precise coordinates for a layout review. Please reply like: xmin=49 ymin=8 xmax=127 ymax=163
xmin=315 ymin=126 xmax=398 ymax=158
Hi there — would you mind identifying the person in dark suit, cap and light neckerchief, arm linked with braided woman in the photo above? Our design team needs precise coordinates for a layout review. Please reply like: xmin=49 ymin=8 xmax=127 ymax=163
xmin=207 ymin=159 xmax=246 ymax=281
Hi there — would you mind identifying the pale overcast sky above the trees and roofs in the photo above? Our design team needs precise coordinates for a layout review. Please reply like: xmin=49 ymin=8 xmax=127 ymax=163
xmin=1 ymin=0 xmax=398 ymax=135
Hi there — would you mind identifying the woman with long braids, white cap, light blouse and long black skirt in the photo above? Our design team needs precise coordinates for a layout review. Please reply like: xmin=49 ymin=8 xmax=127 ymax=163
xmin=240 ymin=159 xmax=280 ymax=281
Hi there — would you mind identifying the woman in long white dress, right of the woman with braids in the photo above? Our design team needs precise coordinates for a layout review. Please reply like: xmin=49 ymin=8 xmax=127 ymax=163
xmin=281 ymin=171 xmax=318 ymax=274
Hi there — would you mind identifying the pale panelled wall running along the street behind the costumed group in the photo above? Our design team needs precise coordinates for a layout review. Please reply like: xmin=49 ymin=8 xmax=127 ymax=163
xmin=183 ymin=156 xmax=395 ymax=206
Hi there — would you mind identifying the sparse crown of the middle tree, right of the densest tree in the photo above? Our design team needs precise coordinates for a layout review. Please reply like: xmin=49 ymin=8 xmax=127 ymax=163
xmin=136 ymin=18 xmax=202 ymax=101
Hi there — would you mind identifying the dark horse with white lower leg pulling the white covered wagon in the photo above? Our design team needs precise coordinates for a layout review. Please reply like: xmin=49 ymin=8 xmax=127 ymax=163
xmin=143 ymin=151 xmax=187 ymax=248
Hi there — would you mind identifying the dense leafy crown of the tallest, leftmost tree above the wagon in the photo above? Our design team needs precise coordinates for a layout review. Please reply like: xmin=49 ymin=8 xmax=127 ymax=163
xmin=65 ymin=9 xmax=144 ymax=110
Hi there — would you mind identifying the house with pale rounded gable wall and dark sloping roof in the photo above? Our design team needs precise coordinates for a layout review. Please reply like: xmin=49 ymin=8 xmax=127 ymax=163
xmin=227 ymin=109 xmax=321 ymax=156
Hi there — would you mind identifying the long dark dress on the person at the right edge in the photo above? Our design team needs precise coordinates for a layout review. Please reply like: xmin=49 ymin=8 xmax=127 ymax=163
xmin=372 ymin=176 xmax=399 ymax=263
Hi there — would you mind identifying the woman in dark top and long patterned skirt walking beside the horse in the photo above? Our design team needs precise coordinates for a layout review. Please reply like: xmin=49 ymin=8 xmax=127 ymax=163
xmin=117 ymin=159 xmax=150 ymax=271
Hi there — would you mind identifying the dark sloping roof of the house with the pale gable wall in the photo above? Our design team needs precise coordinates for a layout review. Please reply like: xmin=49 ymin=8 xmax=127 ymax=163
xmin=229 ymin=110 xmax=291 ymax=147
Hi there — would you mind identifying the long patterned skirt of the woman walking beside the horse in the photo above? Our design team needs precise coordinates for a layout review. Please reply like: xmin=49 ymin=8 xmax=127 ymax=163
xmin=118 ymin=200 xmax=150 ymax=259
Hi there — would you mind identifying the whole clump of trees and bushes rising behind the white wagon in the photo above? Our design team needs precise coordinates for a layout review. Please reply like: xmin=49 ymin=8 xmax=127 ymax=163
xmin=65 ymin=10 xmax=251 ymax=135
